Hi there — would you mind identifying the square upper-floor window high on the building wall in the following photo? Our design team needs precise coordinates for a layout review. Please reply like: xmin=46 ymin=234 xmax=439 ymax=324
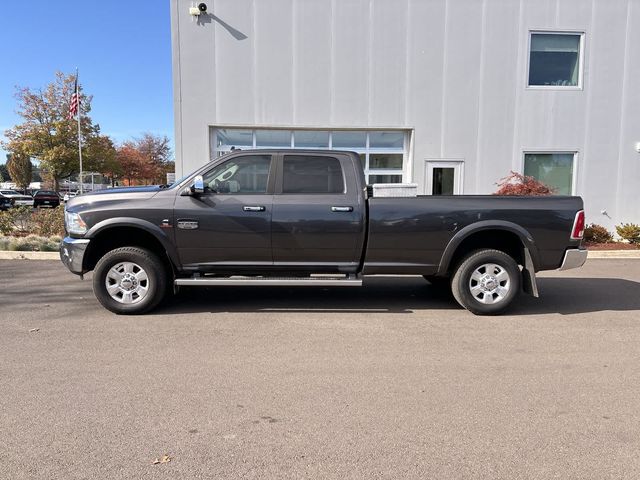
xmin=528 ymin=32 xmax=584 ymax=88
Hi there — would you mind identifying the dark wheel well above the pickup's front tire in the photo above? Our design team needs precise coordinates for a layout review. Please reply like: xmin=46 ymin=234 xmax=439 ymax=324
xmin=83 ymin=227 xmax=174 ymax=272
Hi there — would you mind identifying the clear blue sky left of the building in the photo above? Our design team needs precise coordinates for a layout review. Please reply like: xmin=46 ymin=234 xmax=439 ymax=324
xmin=0 ymin=0 xmax=173 ymax=163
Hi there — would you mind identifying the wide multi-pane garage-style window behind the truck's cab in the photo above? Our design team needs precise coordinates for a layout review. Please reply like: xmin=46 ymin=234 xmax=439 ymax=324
xmin=211 ymin=128 xmax=409 ymax=184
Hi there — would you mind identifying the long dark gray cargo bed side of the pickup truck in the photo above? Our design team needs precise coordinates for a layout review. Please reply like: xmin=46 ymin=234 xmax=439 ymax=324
xmin=364 ymin=195 xmax=583 ymax=274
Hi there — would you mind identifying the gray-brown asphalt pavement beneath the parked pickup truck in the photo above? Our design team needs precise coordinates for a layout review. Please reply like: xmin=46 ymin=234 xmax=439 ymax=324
xmin=0 ymin=260 xmax=640 ymax=480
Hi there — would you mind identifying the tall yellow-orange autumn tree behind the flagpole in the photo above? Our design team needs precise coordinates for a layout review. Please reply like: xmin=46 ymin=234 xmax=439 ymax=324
xmin=2 ymin=72 xmax=115 ymax=190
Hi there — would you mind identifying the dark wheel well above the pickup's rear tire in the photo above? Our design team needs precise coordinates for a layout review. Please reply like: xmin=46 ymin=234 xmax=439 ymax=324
xmin=447 ymin=229 xmax=525 ymax=275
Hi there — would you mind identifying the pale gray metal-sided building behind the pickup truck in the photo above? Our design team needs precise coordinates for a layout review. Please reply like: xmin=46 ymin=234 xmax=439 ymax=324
xmin=171 ymin=0 xmax=640 ymax=228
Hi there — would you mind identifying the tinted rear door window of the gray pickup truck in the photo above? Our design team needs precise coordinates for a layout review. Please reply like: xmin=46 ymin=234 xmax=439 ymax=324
xmin=282 ymin=155 xmax=344 ymax=193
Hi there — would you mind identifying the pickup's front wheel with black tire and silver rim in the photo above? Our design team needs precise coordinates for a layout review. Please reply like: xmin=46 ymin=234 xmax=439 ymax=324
xmin=93 ymin=247 xmax=169 ymax=315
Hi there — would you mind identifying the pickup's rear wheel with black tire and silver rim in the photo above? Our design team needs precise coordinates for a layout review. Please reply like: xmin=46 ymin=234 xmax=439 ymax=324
xmin=451 ymin=249 xmax=521 ymax=315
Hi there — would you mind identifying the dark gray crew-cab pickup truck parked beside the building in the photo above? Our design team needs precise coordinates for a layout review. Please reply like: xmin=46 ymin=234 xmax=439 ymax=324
xmin=60 ymin=150 xmax=587 ymax=315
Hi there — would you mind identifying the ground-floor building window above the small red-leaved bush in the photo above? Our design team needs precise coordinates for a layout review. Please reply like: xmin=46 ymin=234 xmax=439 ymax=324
xmin=524 ymin=152 xmax=576 ymax=195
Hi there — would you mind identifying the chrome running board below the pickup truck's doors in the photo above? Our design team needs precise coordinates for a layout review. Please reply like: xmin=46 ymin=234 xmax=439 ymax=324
xmin=174 ymin=275 xmax=362 ymax=287
